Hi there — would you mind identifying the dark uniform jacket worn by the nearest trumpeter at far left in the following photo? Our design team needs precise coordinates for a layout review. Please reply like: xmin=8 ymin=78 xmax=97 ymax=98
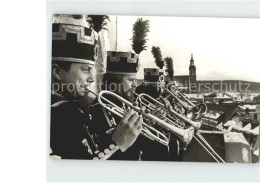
xmin=50 ymin=95 xmax=97 ymax=159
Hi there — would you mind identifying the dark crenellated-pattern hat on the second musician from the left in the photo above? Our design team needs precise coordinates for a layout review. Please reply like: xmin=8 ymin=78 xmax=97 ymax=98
xmin=107 ymin=51 xmax=139 ymax=75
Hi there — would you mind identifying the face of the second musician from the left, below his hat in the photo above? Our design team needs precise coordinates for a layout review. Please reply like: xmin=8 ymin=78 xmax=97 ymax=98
xmin=118 ymin=74 xmax=137 ymax=100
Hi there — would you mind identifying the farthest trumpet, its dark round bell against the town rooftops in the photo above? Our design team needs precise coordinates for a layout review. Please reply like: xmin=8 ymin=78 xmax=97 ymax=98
xmin=164 ymin=87 xmax=208 ymax=120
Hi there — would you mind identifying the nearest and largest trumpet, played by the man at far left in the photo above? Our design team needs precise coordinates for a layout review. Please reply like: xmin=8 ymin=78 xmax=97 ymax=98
xmin=88 ymin=89 xmax=194 ymax=145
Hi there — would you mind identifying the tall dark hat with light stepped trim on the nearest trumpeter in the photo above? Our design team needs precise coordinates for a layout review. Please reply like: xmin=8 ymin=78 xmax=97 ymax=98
xmin=52 ymin=14 xmax=97 ymax=65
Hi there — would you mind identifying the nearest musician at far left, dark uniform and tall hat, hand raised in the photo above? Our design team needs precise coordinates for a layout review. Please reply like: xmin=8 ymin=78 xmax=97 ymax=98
xmin=50 ymin=15 xmax=142 ymax=159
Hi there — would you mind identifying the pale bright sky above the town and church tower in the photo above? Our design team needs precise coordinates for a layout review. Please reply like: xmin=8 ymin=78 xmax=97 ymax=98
xmin=117 ymin=16 xmax=260 ymax=82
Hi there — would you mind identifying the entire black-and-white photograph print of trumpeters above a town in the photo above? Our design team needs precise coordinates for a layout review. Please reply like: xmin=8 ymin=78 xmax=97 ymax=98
xmin=49 ymin=14 xmax=260 ymax=163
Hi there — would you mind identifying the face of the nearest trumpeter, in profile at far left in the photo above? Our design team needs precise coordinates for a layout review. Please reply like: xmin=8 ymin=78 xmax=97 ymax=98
xmin=60 ymin=63 xmax=94 ymax=99
